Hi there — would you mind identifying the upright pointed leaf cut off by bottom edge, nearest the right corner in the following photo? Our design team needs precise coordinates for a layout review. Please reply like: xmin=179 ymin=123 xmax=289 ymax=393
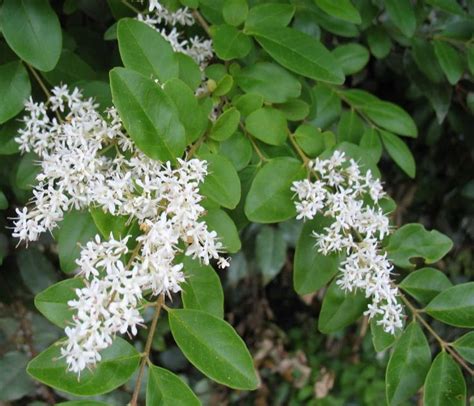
xmin=423 ymin=351 xmax=466 ymax=406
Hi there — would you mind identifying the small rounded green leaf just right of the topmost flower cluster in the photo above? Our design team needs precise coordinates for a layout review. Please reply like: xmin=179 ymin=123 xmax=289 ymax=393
xmin=211 ymin=24 xmax=252 ymax=61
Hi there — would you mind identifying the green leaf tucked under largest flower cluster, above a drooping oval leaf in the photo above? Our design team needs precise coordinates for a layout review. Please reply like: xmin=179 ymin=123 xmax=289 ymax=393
xmin=181 ymin=257 xmax=224 ymax=319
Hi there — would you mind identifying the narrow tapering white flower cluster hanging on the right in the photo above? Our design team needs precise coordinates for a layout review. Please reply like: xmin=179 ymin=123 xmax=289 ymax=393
xmin=291 ymin=151 xmax=403 ymax=334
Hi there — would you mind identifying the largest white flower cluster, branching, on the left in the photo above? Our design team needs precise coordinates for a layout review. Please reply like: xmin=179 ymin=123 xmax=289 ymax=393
xmin=13 ymin=87 xmax=228 ymax=373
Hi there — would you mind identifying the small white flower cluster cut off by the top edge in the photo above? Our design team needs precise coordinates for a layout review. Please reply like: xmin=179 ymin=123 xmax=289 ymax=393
xmin=137 ymin=0 xmax=214 ymax=68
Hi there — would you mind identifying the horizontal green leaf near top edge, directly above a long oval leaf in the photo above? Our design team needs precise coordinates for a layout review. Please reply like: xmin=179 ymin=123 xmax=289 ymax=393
xmin=245 ymin=2 xmax=295 ymax=31
